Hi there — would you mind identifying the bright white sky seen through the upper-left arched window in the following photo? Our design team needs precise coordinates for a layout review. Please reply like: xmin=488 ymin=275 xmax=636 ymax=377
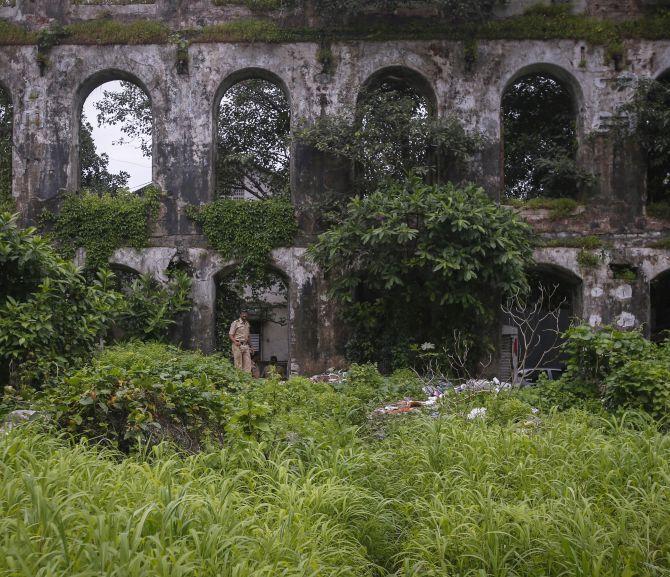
xmin=83 ymin=81 xmax=151 ymax=190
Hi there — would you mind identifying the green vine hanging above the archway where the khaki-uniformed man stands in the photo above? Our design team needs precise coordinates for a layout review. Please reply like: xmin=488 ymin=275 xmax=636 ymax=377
xmin=187 ymin=198 xmax=298 ymax=285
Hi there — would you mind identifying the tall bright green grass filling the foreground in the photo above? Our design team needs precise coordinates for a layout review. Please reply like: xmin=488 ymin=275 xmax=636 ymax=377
xmin=0 ymin=410 xmax=670 ymax=577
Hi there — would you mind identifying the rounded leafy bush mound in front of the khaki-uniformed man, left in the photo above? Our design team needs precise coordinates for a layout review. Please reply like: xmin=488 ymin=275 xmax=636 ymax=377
xmin=40 ymin=342 xmax=248 ymax=451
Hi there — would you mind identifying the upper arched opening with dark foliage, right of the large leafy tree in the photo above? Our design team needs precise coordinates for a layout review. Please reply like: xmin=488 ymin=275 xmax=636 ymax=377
xmin=502 ymin=72 xmax=589 ymax=200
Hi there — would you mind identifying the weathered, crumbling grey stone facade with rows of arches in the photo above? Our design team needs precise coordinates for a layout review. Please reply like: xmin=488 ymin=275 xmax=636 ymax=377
xmin=0 ymin=0 xmax=670 ymax=372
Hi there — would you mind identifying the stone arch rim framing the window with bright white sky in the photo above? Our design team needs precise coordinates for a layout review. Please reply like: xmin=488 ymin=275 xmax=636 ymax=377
xmin=68 ymin=68 xmax=157 ymax=190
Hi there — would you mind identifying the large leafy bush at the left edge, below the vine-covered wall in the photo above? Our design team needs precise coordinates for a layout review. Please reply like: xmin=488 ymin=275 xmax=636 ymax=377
xmin=0 ymin=213 xmax=120 ymax=386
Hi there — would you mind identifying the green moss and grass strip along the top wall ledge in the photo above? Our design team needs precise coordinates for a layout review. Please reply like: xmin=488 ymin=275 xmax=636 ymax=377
xmin=0 ymin=7 xmax=670 ymax=47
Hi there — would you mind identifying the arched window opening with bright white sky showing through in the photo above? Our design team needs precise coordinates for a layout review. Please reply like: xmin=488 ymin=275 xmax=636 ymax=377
xmin=79 ymin=75 xmax=153 ymax=192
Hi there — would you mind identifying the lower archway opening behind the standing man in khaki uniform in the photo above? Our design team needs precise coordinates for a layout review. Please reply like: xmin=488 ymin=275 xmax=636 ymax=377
xmin=216 ymin=269 xmax=289 ymax=375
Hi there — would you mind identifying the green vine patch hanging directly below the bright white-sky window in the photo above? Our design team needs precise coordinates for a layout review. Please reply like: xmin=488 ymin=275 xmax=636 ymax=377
xmin=43 ymin=186 xmax=160 ymax=270
